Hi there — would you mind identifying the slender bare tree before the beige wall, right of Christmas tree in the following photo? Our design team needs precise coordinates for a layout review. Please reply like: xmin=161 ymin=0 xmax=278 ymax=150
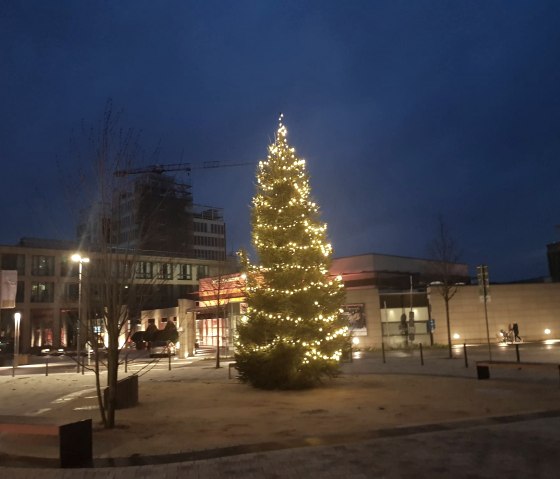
xmin=429 ymin=215 xmax=461 ymax=358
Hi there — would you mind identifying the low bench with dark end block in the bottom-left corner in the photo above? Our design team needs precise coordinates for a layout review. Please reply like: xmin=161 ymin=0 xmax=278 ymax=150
xmin=0 ymin=416 xmax=93 ymax=468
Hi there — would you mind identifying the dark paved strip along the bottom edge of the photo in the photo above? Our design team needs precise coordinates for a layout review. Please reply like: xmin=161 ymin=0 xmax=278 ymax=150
xmin=0 ymin=417 xmax=560 ymax=479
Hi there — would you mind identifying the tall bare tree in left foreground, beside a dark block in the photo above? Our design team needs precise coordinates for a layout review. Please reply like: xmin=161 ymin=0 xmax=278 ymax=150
xmin=70 ymin=101 xmax=164 ymax=428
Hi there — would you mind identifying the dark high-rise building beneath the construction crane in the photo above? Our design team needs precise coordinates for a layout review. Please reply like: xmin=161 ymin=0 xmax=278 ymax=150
xmin=78 ymin=171 xmax=226 ymax=261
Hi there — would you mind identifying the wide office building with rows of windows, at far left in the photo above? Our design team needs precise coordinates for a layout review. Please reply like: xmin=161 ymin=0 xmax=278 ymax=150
xmin=0 ymin=238 xmax=230 ymax=352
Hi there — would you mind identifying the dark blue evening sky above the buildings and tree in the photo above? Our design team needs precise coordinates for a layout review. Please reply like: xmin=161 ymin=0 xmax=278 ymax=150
xmin=0 ymin=0 xmax=560 ymax=281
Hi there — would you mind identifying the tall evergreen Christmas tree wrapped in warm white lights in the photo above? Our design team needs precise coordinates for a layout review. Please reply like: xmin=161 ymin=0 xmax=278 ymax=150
xmin=235 ymin=116 xmax=349 ymax=389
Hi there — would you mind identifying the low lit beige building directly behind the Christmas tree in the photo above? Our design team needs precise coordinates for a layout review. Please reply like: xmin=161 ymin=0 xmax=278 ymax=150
xmin=145 ymin=254 xmax=560 ymax=350
